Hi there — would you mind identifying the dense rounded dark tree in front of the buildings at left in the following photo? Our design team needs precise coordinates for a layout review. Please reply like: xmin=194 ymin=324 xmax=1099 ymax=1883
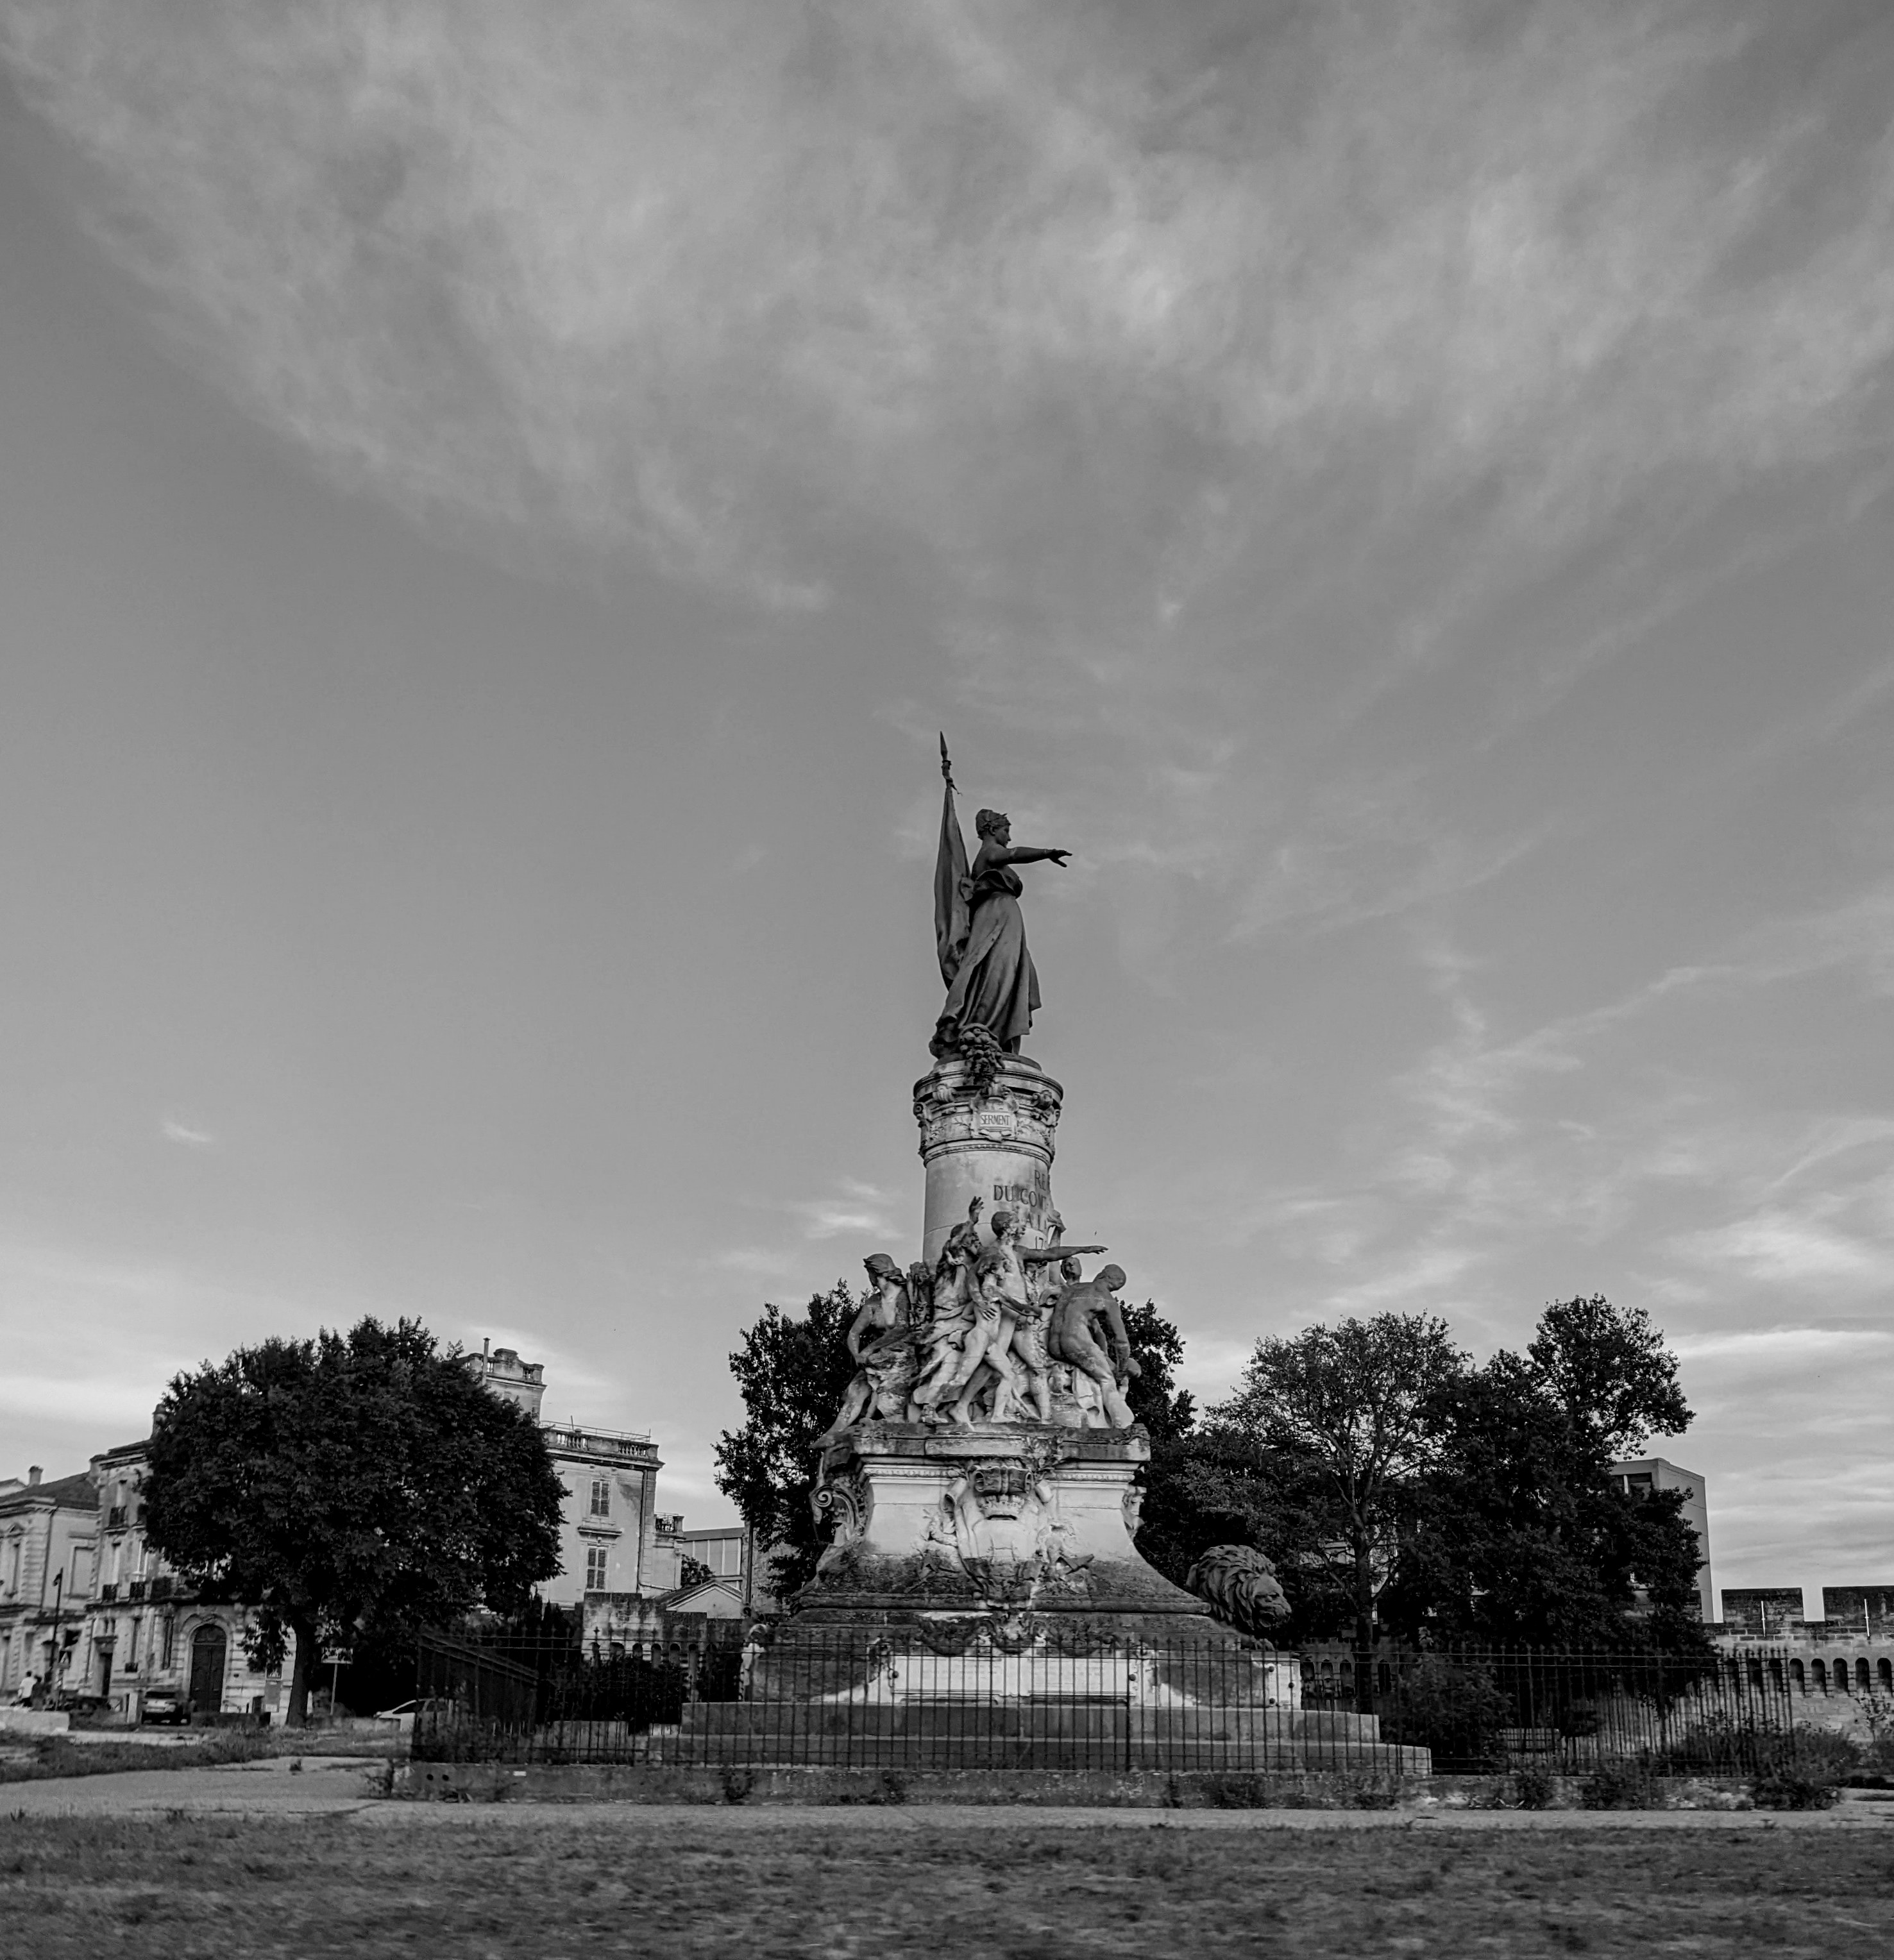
xmin=145 ymin=1319 xmax=564 ymax=1725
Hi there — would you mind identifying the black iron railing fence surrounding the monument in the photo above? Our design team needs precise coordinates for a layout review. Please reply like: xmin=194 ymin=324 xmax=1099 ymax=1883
xmin=412 ymin=1626 xmax=1798 ymax=1776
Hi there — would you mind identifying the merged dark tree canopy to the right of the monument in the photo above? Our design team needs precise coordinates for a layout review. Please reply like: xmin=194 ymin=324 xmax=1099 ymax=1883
xmin=1137 ymin=1297 xmax=1702 ymax=1652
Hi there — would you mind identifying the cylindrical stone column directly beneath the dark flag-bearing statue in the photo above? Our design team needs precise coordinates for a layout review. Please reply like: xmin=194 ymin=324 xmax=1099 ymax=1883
xmin=914 ymin=1054 xmax=1065 ymax=1264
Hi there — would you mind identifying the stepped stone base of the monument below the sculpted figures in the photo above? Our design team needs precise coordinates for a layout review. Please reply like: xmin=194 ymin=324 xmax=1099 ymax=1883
xmin=677 ymin=1421 xmax=1430 ymax=1776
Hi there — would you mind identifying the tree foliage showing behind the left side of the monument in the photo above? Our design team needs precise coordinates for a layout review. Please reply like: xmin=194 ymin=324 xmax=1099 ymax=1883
xmin=716 ymin=1280 xmax=859 ymax=1598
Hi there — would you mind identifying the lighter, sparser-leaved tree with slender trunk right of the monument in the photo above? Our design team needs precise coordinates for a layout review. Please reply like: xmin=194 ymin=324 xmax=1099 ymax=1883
xmin=1210 ymin=1314 xmax=1467 ymax=1707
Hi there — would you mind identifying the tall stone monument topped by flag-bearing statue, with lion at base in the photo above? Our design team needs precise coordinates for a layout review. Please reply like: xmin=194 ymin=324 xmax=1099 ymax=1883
xmin=686 ymin=739 xmax=1349 ymax=1764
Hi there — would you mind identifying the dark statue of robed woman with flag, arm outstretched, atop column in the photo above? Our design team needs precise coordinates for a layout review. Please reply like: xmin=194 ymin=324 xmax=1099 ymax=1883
xmin=929 ymin=735 xmax=1072 ymax=1054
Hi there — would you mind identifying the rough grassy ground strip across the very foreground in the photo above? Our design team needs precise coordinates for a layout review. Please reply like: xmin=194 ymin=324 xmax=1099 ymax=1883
xmin=0 ymin=1804 xmax=1894 ymax=1960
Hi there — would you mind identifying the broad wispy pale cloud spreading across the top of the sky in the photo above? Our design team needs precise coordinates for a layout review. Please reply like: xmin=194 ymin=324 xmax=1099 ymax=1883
xmin=4 ymin=0 xmax=1894 ymax=623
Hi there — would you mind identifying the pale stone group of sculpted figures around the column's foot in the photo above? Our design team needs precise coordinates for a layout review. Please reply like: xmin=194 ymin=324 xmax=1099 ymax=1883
xmin=833 ymin=1197 xmax=1139 ymax=1431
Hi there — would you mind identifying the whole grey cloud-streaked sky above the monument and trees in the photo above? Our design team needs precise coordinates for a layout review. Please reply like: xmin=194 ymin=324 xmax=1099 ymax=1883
xmin=0 ymin=0 xmax=1894 ymax=1605
